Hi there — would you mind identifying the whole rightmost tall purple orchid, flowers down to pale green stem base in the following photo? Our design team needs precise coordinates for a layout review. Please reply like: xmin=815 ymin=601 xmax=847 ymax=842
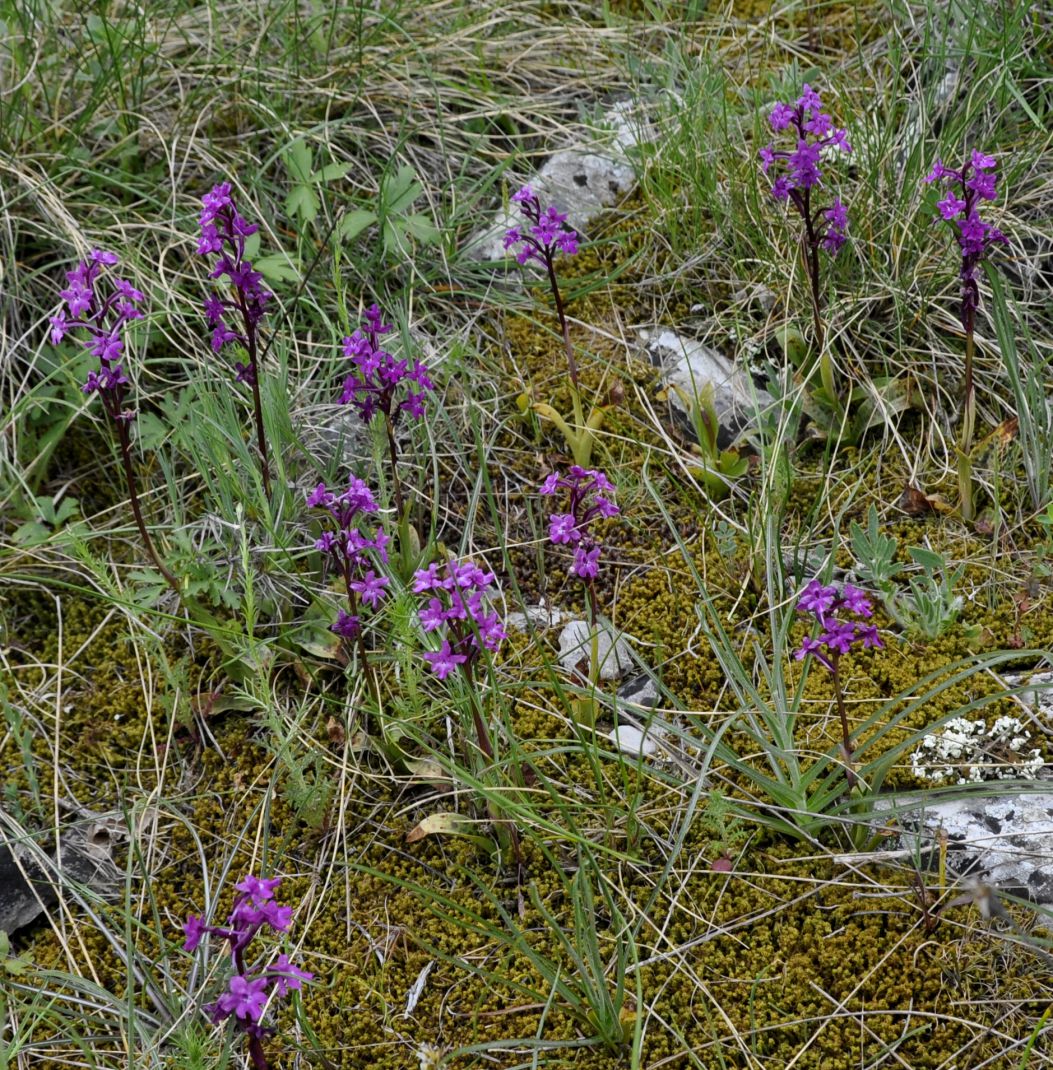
xmin=925 ymin=149 xmax=1009 ymax=520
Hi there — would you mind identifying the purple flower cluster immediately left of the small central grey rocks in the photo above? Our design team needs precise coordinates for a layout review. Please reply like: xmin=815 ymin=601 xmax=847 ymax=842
xmin=413 ymin=561 xmax=505 ymax=679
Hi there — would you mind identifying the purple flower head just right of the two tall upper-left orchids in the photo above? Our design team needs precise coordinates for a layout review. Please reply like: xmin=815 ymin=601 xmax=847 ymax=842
xmin=340 ymin=305 xmax=434 ymax=425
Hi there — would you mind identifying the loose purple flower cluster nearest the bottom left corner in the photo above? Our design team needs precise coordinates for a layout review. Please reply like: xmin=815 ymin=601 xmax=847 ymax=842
xmin=183 ymin=876 xmax=315 ymax=1040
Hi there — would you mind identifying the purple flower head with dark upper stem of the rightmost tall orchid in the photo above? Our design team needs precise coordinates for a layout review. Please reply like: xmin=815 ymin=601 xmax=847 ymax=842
xmin=925 ymin=149 xmax=1009 ymax=331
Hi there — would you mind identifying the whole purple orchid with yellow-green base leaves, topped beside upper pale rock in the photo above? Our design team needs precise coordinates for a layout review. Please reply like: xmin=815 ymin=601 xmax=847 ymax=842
xmin=504 ymin=185 xmax=604 ymax=464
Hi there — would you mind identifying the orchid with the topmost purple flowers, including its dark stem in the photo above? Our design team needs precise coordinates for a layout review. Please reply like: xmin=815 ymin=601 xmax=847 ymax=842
xmin=758 ymin=83 xmax=852 ymax=406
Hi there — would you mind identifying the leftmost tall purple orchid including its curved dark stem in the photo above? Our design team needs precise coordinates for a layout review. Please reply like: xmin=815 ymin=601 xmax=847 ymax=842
xmin=50 ymin=249 xmax=182 ymax=594
